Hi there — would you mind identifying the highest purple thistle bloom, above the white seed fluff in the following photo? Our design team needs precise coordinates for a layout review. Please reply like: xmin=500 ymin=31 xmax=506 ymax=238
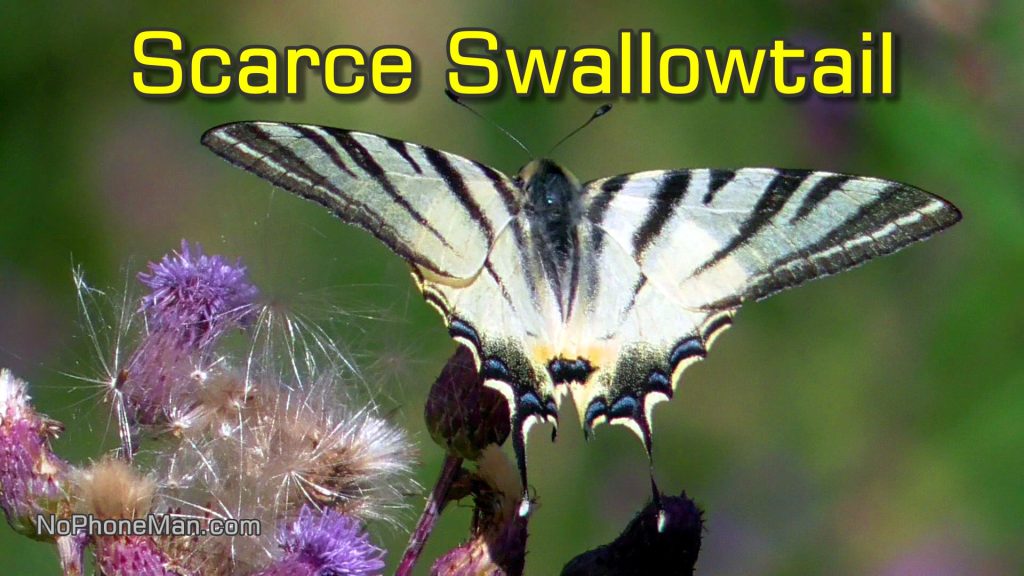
xmin=138 ymin=240 xmax=258 ymax=347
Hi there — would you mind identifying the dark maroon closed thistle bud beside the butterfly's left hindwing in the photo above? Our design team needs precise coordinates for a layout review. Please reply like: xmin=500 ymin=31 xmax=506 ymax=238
xmin=425 ymin=346 xmax=510 ymax=460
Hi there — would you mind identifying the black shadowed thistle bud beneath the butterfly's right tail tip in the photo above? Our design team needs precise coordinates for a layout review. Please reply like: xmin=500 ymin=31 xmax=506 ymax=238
xmin=562 ymin=492 xmax=703 ymax=576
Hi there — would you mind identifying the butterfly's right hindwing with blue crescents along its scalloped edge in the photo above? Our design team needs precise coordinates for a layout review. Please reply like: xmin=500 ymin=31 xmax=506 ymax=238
xmin=563 ymin=215 xmax=732 ymax=450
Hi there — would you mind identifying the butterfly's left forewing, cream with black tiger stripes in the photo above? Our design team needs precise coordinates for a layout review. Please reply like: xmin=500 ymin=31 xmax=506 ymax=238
xmin=203 ymin=122 xmax=519 ymax=283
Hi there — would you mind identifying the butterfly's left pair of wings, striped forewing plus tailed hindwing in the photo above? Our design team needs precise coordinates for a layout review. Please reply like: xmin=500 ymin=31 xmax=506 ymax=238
xmin=203 ymin=122 xmax=557 ymax=502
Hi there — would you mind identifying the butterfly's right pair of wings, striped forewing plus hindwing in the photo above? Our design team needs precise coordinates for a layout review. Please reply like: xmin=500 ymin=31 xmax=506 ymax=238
xmin=573 ymin=168 xmax=961 ymax=449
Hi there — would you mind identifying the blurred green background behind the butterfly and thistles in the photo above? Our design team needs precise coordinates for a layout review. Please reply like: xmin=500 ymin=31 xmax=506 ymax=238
xmin=0 ymin=0 xmax=1024 ymax=575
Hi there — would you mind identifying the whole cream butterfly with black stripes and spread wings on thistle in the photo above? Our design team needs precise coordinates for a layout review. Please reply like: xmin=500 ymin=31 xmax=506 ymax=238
xmin=203 ymin=122 xmax=961 ymax=513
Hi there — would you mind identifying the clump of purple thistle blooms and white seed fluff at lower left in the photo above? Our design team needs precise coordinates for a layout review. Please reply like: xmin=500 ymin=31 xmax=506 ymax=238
xmin=0 ymin=242 xmax=415 ymax=576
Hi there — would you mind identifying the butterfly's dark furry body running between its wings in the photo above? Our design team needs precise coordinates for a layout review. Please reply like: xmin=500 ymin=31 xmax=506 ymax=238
xmin=517 ymin=159 xmax=583 ymax=320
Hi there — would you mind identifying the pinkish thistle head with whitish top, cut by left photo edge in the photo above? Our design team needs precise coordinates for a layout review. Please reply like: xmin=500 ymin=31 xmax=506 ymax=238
xmin=0 ymin=370 xmax=68 ymax=538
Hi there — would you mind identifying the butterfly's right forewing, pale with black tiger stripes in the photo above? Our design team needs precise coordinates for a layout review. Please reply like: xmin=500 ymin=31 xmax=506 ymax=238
xmin=585 ymin=168 xmax=959 ymax=310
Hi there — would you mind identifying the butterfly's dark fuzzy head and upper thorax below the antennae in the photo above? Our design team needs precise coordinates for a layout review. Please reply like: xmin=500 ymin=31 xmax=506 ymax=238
xmin=516 ymin=158 xmax=582 ymax=220
